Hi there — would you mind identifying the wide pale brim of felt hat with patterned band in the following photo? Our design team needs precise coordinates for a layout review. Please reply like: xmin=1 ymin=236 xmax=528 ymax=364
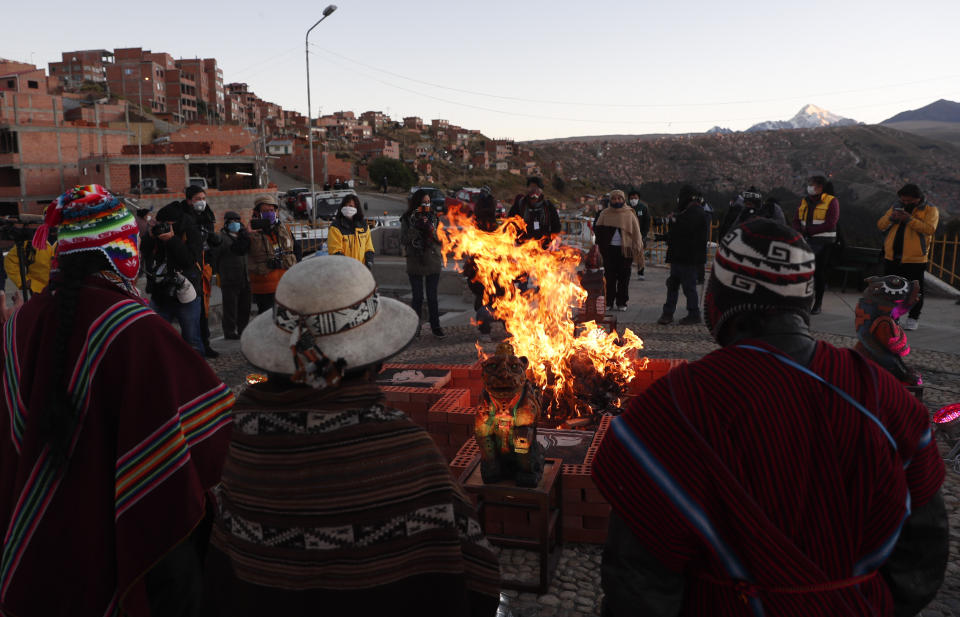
xmin=240 ymin=297 xmax=420 ymax=375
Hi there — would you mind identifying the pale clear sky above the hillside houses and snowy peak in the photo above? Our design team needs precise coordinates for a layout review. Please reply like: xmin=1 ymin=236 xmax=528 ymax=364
xmin=7 ymin=0 xmax=960 ymax=140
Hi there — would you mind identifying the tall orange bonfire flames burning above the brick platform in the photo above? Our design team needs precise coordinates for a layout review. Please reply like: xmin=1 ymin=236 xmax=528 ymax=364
xmin=438 ymin=208 xmax=646 ymax=417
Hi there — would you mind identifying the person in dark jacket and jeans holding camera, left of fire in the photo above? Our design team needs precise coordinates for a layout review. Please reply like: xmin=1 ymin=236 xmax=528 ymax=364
xmin=400 ymin=189 xmax=445 ymax=338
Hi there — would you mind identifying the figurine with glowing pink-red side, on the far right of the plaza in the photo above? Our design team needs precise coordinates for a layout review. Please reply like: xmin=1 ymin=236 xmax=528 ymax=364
xmin=854 ymin=275 xmax=922 ymax=386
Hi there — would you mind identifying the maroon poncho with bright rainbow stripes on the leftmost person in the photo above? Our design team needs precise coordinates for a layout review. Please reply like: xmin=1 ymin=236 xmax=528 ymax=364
xmin=0 ymin=277 xmax=233 ymax=617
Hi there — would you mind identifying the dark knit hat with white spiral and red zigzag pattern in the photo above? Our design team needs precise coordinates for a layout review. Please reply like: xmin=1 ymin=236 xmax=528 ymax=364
xmin=704 ymin=218 xmax=814 ymax=339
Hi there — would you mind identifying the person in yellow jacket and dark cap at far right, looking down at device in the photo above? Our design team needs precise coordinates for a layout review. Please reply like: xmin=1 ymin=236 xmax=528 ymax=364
xmin=877 ymin=184 xmax=940 ymax=330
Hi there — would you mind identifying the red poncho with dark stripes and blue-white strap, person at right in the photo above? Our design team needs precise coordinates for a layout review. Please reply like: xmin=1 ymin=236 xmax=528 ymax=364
xmin=593 ymin=342 xmax=944 ymax=617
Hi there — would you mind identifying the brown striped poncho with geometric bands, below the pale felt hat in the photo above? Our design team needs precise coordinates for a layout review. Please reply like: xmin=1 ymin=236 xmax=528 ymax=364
xmin=207 ymin=381 xmax=499 ymax=616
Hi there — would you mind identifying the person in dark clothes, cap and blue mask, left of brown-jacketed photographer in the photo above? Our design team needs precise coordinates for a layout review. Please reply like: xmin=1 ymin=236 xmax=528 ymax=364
xmin=213 ymin=210 xmax=250 ymax=339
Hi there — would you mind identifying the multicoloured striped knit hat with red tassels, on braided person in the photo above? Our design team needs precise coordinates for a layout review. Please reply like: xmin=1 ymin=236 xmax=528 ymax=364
xmin=33 ymin=184 xmax=140 ymax=281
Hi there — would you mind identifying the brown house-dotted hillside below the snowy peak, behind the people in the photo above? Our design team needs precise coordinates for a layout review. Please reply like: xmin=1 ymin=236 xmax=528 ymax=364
xmin=536 ymin=125 xmax=960 ymax=244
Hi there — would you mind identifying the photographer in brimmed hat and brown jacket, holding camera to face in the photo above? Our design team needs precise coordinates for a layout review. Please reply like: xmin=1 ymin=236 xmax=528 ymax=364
xmin=247 ymin=195 xmax=297 ymax=314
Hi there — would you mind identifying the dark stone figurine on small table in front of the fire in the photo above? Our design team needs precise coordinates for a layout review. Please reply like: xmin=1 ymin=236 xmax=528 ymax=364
xmin=475 ymin=342 xmax=544 ymax=487
